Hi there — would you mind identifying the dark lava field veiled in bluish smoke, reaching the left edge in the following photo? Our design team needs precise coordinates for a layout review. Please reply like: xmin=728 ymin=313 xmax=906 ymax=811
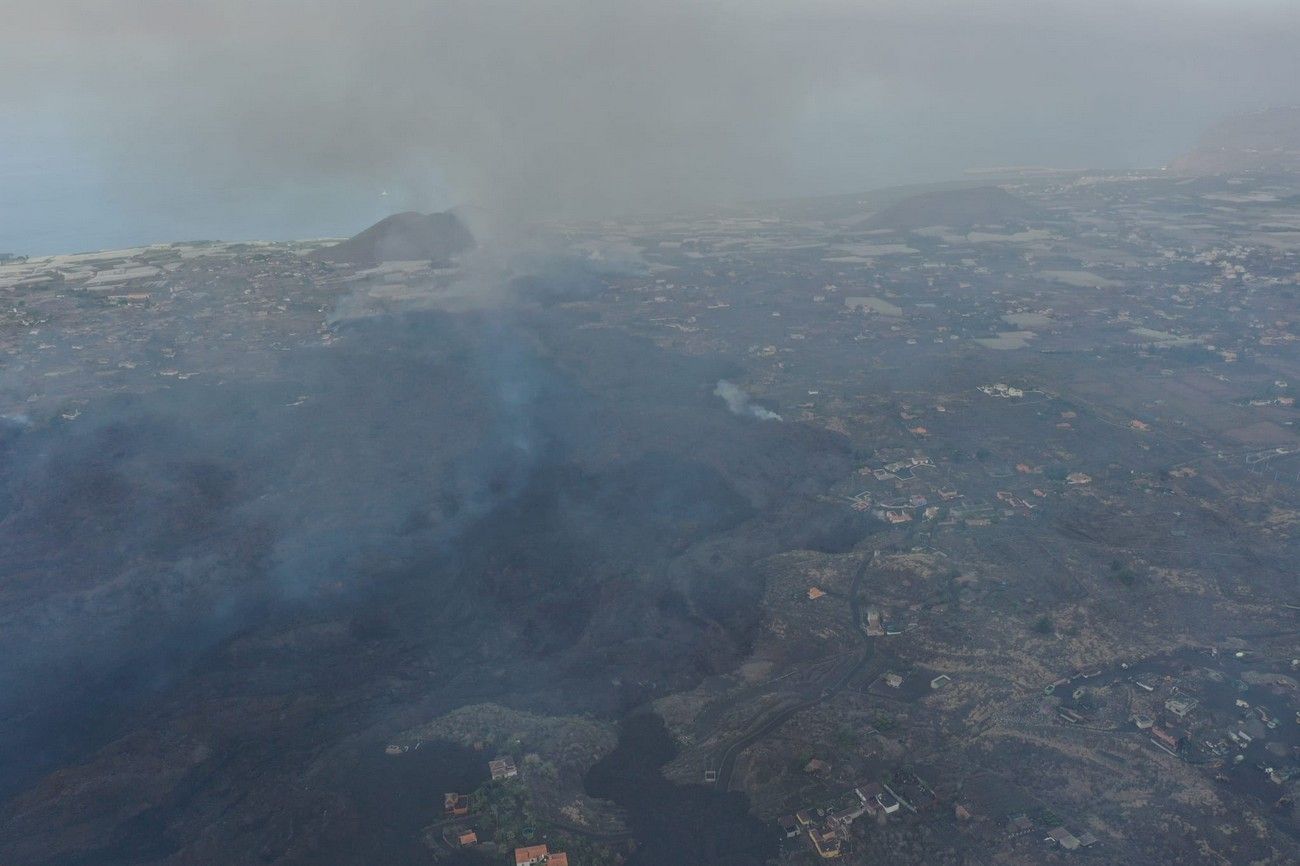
xmin=0 ymin=265 xmax=865 ymax=862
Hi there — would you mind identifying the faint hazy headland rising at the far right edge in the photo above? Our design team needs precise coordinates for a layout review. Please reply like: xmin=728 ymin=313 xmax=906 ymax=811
xmin=1169 ymin=108 xmax=1300 ymax=174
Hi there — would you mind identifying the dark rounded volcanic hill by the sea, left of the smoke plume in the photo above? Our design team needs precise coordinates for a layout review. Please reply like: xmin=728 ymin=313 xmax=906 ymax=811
xmin=311 ymin=211 xmax=475 ymax=265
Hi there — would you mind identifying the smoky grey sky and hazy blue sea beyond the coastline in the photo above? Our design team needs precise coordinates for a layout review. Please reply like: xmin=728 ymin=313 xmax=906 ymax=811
xmin=0 ymin=0 xmax=1300 ymax=252
